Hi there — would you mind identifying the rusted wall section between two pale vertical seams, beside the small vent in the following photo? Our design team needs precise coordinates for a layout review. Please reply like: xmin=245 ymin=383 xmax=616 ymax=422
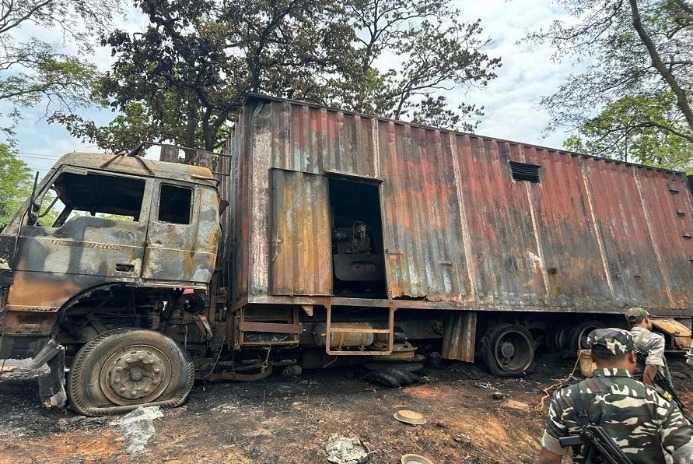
xmin=457 ymin=135 xmax=546 ymax=306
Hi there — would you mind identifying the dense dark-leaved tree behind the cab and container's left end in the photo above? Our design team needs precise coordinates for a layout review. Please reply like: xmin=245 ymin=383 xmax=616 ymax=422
xmin=54 ymin=0 xmax=351 ymax=150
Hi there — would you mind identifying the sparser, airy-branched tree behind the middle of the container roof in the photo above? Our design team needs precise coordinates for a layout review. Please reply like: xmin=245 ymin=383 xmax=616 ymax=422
xmin=336 ymin=0 xmax=501 ymax=130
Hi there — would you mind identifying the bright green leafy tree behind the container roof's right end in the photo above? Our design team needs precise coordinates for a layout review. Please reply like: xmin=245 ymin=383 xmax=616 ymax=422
xmin=564 ymin=92 xmax=693 ymax=171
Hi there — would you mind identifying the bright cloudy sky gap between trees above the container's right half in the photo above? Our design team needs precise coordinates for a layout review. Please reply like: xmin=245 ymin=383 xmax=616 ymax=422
xmin=457 ymin=0 xmax=572 ymax=147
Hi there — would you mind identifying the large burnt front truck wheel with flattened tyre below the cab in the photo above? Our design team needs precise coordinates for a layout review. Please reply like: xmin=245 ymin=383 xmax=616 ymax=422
xmin=68 ymin=329 xmax=195 ymax=416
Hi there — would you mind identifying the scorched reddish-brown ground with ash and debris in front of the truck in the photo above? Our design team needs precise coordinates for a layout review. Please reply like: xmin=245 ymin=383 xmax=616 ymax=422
xmin=0 ymin=356 xmax=693 ymax=464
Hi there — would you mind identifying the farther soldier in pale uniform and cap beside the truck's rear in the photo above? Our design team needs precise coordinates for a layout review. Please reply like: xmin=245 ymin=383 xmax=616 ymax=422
xmin=626 ymin=307 xmax=669 ymax=386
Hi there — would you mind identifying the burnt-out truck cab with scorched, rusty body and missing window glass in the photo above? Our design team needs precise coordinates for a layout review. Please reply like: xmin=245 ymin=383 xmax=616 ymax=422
xmin=2 ymin=153 xmax=220 ymax=330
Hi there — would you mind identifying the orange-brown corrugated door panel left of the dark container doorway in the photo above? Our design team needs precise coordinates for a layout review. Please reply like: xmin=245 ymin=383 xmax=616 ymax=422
xmin=270 ymin=169 xmax=332 ymax=295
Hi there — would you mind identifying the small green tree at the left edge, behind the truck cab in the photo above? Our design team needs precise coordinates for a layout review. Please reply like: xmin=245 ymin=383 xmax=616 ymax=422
xmin=0 ymin=144 xmax=32 ymax=230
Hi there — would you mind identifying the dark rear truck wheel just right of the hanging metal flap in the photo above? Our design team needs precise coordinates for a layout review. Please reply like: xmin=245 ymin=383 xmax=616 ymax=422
xmin=481 ymin=324 xmax=534 ymax=377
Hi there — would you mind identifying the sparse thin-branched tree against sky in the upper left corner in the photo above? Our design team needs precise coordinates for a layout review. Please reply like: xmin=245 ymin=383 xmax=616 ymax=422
xmin=0 ymin=0 xmax=121 ymax=138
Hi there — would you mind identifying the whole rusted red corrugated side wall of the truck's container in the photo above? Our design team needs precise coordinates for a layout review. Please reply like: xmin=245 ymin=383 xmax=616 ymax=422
xmin=231 ymin=99 xmax=693 ymax=311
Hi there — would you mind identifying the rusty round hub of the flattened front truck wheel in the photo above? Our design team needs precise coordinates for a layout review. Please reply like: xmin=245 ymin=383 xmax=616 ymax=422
xmin=100 ymin=346 xmax=170 ymax=404
